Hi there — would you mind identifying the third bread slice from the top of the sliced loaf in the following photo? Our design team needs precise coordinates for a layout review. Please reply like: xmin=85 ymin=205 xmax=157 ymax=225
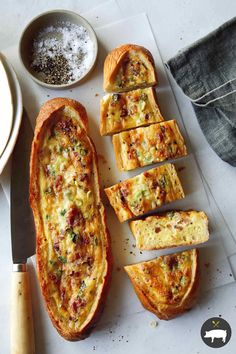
xmin=112 ymin=120 xmax=187 ymax=171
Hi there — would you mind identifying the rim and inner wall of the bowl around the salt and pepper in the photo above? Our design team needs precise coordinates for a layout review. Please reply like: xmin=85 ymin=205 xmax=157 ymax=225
xmin=19 ymin=10 xmax=98 ymax=89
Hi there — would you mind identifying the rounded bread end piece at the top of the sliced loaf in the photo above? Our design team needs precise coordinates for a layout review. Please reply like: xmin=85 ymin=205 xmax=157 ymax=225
xmin=103 ymin=44 xmax=157 ymax=92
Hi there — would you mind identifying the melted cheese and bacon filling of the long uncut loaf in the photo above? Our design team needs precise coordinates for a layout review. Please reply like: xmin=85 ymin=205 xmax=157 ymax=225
xmin=38 ymin=109 xmax=107 ymax=332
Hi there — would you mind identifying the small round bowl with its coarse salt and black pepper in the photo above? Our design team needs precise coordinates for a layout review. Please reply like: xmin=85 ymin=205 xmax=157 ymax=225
xmin=19 ymin=10 xmax=98 ymax=89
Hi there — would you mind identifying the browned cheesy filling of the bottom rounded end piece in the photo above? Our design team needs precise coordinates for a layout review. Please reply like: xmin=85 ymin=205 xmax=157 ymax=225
xmin=125 ymin=249 xmax=197 ymax=312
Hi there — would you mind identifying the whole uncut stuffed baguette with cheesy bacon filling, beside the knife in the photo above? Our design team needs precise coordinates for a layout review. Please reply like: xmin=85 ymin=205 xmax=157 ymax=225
xmin=30 ymin=98 xmax=112 ymax=340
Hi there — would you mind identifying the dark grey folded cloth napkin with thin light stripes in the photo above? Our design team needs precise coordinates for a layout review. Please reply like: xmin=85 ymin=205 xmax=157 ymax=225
xmin=166 ymin=17 xmax=236 ymax=166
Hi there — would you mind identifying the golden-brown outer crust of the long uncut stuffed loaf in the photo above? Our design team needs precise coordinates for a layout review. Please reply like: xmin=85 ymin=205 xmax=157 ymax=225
xmin=30 ymin=98 xmax=112 ymax=341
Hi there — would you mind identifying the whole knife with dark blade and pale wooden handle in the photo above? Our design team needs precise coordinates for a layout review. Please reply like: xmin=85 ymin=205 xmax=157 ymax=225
xmin=10 ymin=112 xmax=35 ymax=354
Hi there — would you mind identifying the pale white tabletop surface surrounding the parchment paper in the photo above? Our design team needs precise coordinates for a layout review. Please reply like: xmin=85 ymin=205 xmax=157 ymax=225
xmin=0 ymin=0 xmax=236 ymax=354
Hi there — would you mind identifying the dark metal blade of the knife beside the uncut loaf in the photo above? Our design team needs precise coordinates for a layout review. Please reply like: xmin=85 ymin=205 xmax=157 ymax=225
xmin=10 ymin=112 xmax=35 ymax=264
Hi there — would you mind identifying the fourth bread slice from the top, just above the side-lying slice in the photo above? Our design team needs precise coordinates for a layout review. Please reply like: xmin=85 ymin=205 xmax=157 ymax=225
xmin=105 ymin=164 xmax=184 ymax=222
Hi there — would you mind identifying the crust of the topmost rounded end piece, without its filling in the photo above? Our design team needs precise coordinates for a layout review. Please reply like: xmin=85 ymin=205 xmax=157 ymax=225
xmin=103 ymin=44 xmax=157 ymax=92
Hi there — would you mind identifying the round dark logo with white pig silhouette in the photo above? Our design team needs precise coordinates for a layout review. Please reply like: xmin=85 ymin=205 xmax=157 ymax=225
xmin=201 ymin=317 xmax=232 ymax=348
